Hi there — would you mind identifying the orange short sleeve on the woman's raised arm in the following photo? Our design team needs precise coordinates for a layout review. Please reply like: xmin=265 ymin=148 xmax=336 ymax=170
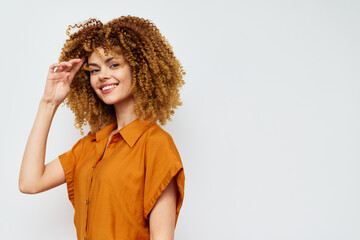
xmin=59 ymin=138 xmax=84 ymax=205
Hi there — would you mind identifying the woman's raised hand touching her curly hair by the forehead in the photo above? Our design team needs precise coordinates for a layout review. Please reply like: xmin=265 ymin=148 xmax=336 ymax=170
xmin=42 ymin=57 xmax=86 ymax=105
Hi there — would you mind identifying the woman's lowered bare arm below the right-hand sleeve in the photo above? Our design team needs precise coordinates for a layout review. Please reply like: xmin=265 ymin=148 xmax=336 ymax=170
xmin=149 ymin=178 xmax=177 ymax=240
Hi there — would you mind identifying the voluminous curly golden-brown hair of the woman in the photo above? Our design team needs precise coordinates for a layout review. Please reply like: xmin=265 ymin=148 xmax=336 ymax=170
xmin=59 ymin=16 xmax=185 ymax=134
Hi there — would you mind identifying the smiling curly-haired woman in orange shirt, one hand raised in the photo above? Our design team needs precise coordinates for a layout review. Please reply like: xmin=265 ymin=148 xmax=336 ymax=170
xmin=19 ymin=16 xmax=185 ymax=240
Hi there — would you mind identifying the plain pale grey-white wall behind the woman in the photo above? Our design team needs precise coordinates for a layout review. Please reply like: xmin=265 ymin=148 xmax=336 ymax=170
xmin=0 ymin=0 xmax=360 ymax=240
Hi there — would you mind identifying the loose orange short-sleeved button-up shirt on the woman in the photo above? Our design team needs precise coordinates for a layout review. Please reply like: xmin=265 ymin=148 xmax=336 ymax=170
xmin=59 ymin=120 xmax=185 ymax=240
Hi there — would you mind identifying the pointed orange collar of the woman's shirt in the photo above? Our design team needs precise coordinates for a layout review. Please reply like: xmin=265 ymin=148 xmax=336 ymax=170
xmin=93 ymin=119 xmax=155 ymax=148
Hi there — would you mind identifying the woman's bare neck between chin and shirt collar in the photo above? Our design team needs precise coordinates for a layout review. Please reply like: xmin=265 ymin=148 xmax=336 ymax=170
xmin=114 ymin=97 xmax=137 ymax=131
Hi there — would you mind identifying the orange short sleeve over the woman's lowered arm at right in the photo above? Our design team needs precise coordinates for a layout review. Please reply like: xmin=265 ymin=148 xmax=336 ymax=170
xmin=144 ymin=132 xmax=185 ymax=224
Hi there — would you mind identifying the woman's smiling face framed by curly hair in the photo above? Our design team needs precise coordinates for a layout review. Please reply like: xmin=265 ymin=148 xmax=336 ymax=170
xmin=88 ymin=48 xmax=134 ymax=105
